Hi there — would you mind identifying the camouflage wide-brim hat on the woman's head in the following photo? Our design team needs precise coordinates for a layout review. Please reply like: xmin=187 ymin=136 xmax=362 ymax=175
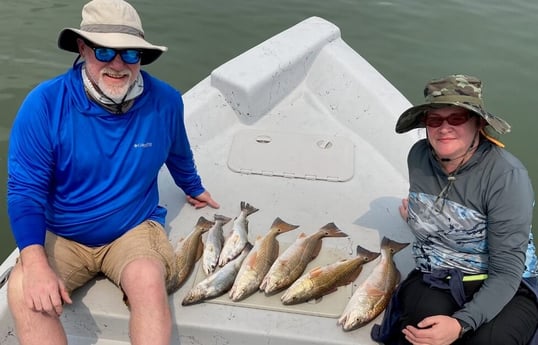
xmin=396 ymin=74 xmax=510 ymax=134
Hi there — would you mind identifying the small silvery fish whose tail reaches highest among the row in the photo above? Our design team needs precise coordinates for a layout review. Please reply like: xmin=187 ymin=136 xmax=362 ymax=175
xmin=219 ymin=201 xmax=258 ymax=267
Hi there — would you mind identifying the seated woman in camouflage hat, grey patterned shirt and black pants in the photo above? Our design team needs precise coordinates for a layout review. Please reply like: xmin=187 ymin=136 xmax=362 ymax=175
xmin=372 ymin=75 xmax=538 ymax=345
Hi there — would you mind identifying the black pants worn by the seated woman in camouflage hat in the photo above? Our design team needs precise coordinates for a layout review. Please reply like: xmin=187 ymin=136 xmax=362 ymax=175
xmin=398 ymin=271 xmax=538 ymax=345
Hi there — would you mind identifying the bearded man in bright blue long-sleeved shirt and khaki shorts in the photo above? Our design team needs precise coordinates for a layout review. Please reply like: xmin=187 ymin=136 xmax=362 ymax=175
xmin=4 ymin=0 xmax=219 ymax=345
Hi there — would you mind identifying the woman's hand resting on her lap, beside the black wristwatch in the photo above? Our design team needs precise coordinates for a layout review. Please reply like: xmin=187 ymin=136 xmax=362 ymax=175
xmin=402 ymin=315 xmax=461 ymax=345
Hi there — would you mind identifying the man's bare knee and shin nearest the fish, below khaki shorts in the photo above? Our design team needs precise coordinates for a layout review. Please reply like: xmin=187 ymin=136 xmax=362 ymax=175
xmin=121 ymin=258 xmax=172 ymax=345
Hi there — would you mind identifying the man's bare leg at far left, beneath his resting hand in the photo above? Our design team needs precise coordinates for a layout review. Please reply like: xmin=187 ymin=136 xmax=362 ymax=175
xmin=8 ymin=263 xmax=67 ymax=345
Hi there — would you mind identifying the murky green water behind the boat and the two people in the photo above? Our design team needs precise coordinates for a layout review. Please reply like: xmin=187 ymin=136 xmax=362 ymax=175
xmin=0 ymin=0 xmax=538 ymax=260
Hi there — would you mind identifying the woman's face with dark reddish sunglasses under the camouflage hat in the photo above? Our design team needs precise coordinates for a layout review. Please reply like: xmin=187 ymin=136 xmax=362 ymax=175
xmin=424 ymin=106 xmax=481 ymax=160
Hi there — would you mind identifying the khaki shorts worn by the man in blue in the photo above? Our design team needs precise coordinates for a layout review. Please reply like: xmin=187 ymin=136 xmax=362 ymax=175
xmin=45 ymin=220 xmax=174 ymax=293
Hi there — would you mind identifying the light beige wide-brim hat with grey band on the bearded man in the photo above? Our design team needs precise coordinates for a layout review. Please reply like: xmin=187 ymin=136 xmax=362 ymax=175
xmin=58 ymin=0 xmax=168 ymax=65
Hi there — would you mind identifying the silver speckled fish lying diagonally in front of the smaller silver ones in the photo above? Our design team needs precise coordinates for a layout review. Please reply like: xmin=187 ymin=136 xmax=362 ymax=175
xmin=181 ymin=243 xmax=252 ymax=306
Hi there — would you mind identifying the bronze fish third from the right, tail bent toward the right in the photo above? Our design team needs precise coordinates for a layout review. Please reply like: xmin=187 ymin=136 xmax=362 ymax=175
xmin=260 ymin=223 xmax=348 ymax=295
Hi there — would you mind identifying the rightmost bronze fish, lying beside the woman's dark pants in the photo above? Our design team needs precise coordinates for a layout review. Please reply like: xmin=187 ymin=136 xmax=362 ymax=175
xmin=337 ymin=237 xmax=409 ymax=331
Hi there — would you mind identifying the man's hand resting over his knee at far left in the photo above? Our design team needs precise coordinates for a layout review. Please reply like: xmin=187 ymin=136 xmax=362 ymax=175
xmin=21 ymin=245 xmax=72 ymax=316
